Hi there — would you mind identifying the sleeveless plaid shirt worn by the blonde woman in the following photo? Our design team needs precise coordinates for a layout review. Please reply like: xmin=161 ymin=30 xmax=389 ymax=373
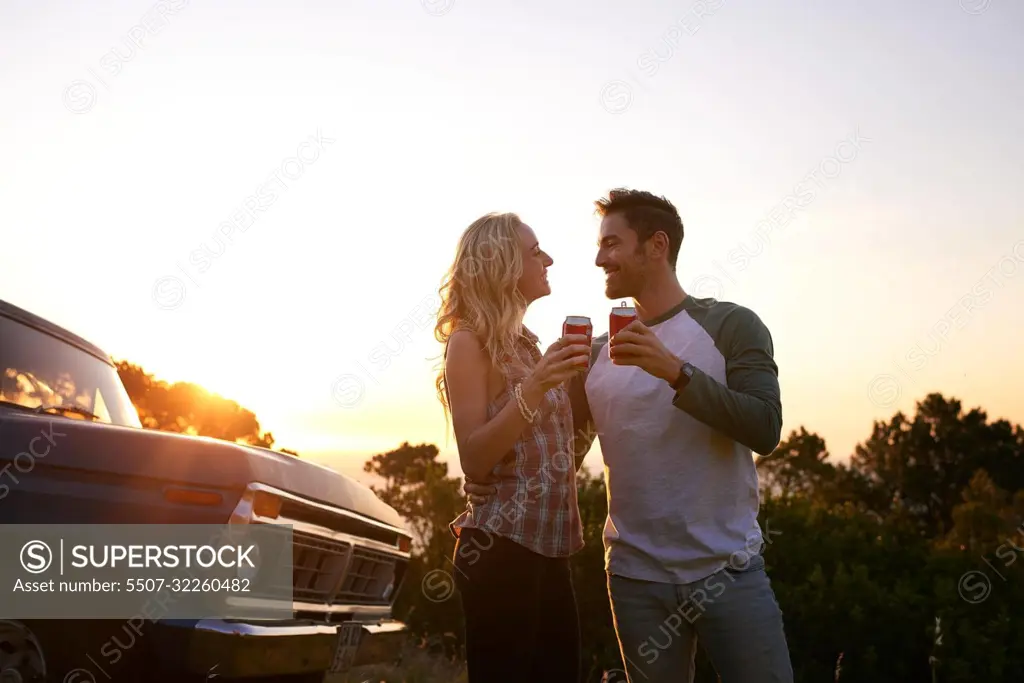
xmin=450 ymin=328 xmax=584 ymax=557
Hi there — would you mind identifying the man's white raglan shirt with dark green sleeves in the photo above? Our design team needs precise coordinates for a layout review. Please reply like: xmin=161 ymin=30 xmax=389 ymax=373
xmin=577 ymin=297 xmax=782 ymax=584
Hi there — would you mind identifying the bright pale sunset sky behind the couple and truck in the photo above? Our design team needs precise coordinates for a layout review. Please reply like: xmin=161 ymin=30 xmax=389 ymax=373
xmin=0 ymin=0 xmax=1024 ymax=481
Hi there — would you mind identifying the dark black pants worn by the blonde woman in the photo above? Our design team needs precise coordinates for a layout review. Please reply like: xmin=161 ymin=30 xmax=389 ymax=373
xmin=455 ymin=528 xmax=580 ymax=683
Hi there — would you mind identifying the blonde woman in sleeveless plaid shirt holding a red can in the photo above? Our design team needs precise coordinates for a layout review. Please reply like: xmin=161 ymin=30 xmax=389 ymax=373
xmin=434 ymin=213 xmax=590 ymax=683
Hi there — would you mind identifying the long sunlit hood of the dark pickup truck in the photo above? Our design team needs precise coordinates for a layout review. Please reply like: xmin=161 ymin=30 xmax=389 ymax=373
xmin=0 ymin=410 xmax=406 ymax=530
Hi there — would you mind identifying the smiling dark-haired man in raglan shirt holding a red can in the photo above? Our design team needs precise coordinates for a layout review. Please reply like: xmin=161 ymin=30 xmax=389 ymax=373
xmin=466 ymin=189 xmax=793 ymax=683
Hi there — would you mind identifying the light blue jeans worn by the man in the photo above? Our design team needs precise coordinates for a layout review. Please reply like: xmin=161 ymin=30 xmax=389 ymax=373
xmin=608 ymin=555 xmax=793 ymax=683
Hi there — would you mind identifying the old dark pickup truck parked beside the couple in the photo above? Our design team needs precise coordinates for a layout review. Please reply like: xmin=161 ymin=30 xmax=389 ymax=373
xmin=0 ymin=301 xmax=412 ymax=683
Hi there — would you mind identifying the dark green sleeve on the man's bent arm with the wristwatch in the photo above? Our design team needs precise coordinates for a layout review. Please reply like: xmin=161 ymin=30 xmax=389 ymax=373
xmin=672 ymin=303 xmax=782 ymax=456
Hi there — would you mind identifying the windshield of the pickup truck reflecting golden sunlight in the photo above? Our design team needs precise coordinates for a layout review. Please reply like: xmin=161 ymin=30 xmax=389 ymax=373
xmin=0 ymin=315 xmax=142 ymax=428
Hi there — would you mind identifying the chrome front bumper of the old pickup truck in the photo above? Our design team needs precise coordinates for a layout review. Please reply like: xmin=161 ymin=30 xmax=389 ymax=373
xmin=153 ymin=620 xmax=408 ymax=678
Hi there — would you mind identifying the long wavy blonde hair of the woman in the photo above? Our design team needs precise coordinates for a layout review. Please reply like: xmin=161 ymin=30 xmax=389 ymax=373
xmin=434 ymin=213 xmax=526 ymax=419
